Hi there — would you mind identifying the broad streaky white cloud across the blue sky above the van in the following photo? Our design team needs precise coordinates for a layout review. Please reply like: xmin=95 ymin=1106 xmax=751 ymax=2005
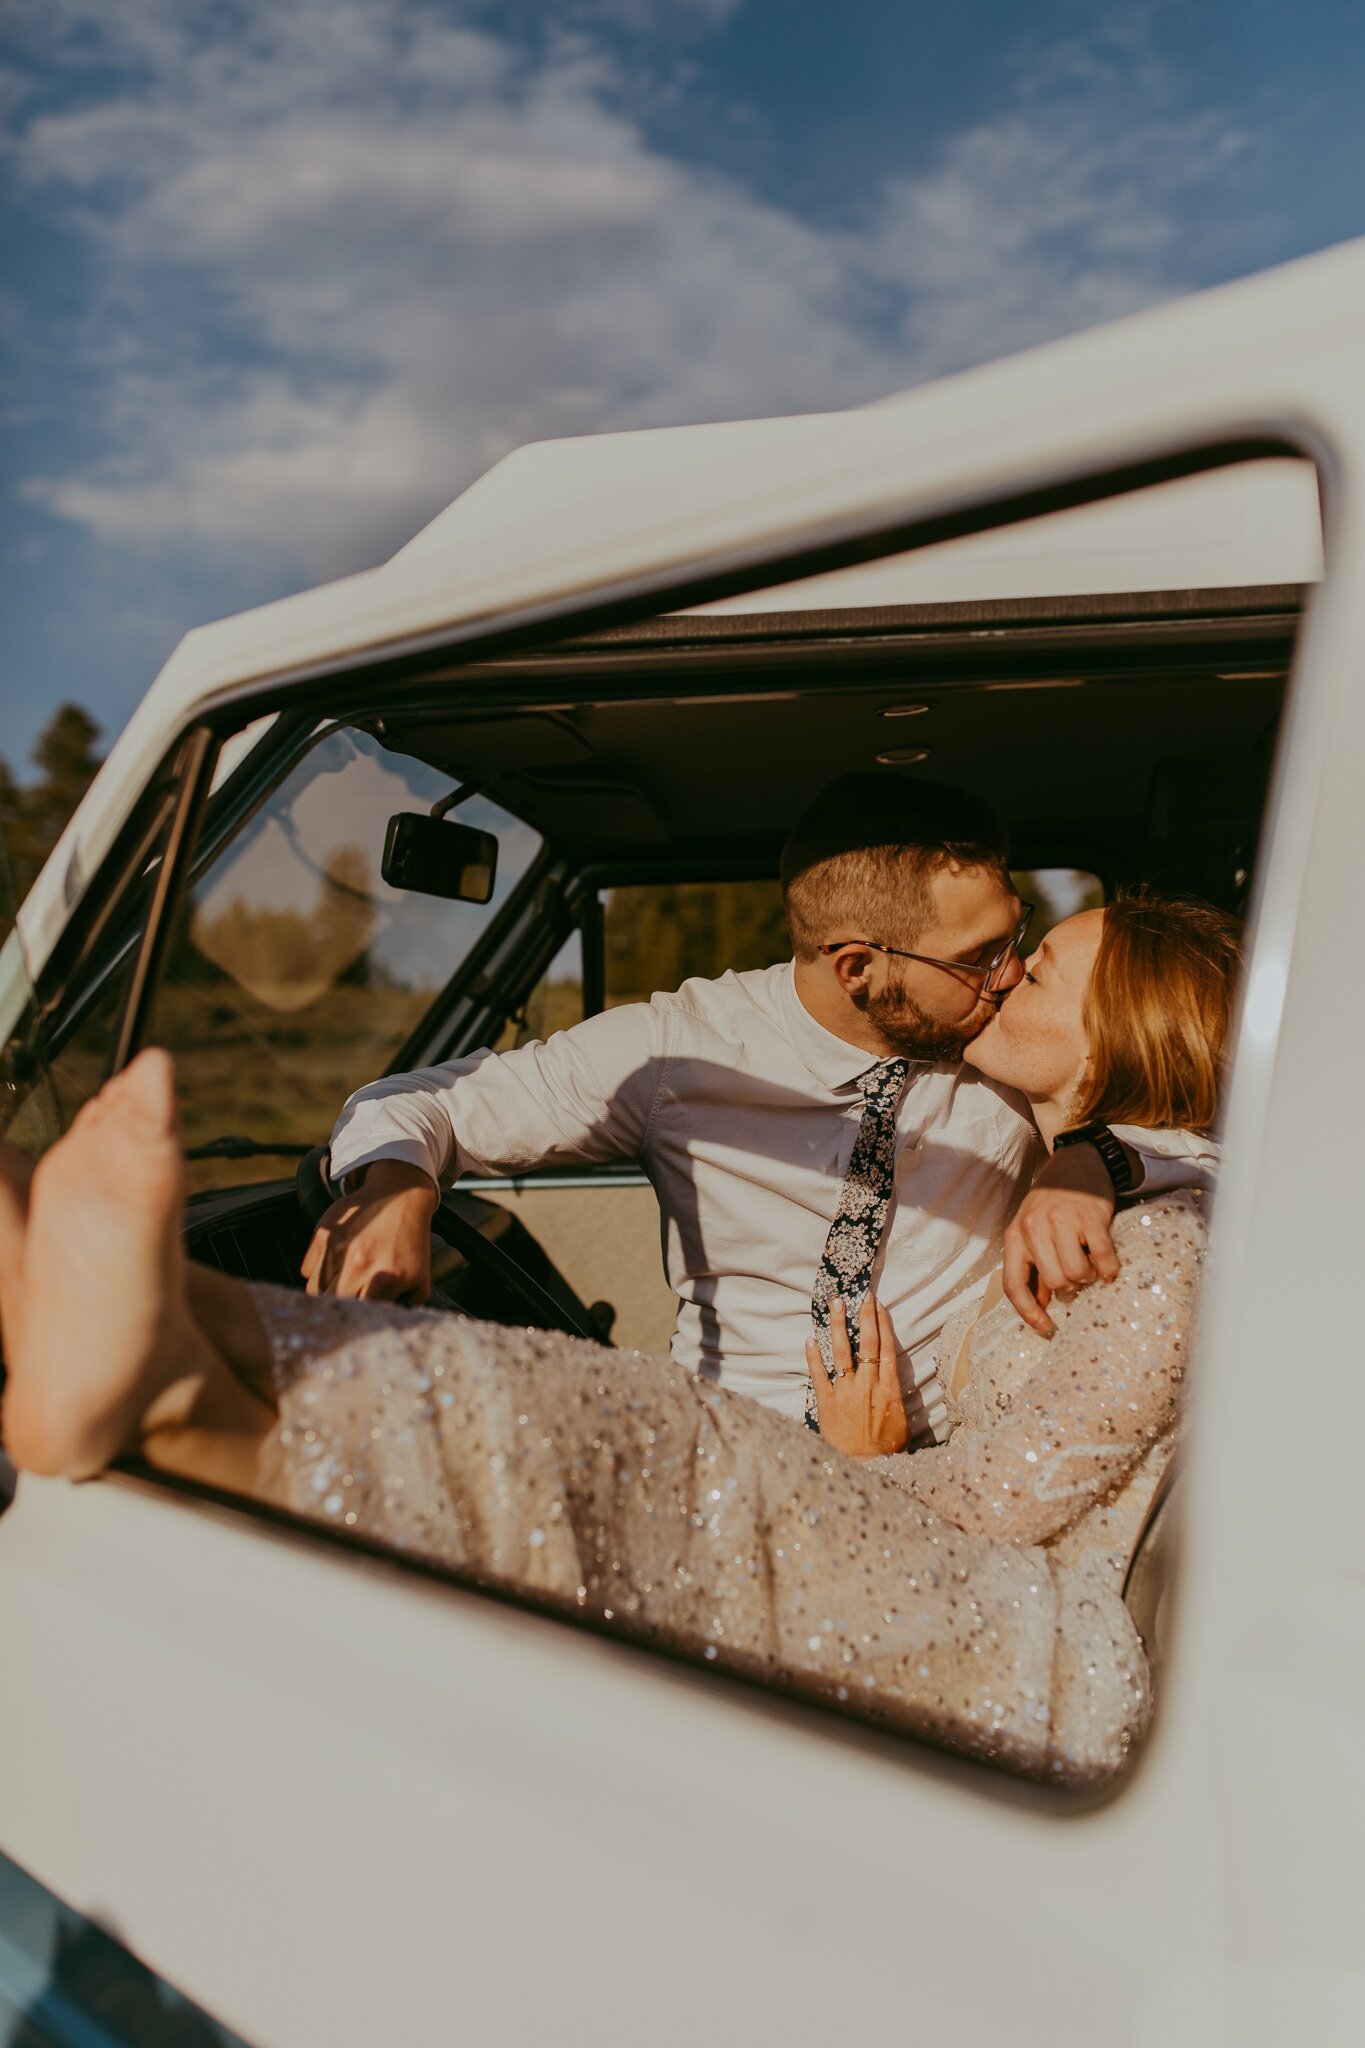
xmin=7 ymin=0 xmax=1240 ymax=578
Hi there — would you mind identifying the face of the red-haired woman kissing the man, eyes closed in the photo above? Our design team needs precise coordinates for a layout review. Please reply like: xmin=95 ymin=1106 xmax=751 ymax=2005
xmin=962 ymin=909 xmax=1105 ymax=1104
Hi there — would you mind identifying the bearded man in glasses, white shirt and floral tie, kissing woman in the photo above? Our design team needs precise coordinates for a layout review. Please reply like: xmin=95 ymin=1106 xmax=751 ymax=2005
xmin=303 ymin=774 xmax=1189 ymax=1442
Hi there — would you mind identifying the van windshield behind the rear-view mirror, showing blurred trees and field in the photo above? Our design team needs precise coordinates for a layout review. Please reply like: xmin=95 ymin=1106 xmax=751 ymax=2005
xmin=149 ymin=727 xmax=542 ymax=1190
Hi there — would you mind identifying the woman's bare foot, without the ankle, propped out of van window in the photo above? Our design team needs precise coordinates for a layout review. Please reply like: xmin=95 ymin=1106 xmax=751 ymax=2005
xmin=0 ymin=1051 xmax=221 ymax=1479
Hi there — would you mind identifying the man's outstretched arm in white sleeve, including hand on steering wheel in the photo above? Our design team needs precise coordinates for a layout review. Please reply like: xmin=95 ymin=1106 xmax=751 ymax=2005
xmin=303 ymin=1004 xmax=667 ymax=1300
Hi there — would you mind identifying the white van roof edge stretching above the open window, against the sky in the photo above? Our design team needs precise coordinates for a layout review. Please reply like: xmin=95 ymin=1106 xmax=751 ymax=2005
xmin=10 ymin=242 xmax=1365 ymax=969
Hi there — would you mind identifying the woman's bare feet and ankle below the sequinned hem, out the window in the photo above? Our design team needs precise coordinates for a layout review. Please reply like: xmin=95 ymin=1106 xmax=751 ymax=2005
xmin=0 ymin=1051 xmax=274 ymax=1491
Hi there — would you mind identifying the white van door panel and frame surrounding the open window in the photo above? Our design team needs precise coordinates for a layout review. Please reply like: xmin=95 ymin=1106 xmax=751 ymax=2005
xmin=0 ymin=252 xmax=1365 ymax=2048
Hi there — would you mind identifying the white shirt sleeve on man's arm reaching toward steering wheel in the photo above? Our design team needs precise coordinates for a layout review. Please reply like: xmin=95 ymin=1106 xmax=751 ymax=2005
xmin=332 ymin=1004 xmax=669 ymax=1186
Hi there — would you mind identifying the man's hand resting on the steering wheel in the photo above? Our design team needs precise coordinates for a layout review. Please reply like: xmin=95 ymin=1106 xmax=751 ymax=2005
xmin=301 ymin=1159 xmax=440 ymax=1303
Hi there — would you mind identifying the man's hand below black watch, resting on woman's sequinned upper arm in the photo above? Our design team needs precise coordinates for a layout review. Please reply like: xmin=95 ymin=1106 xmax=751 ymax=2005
xmin=1001 ymin=1145 xmax=1119 ymax=1337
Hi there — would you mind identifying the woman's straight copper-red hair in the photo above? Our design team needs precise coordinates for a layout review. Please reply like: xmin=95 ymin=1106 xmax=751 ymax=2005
xmin=1070 ymin=889 xmax=1242 ymax=1130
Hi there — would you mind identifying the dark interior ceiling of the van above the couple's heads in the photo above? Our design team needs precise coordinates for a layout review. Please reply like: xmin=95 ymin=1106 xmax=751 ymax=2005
xmin=370 ymin=586 xmax=1306 ymax=909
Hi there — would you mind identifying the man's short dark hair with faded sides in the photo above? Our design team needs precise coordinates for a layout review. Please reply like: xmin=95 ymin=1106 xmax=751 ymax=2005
xmin=780 ymin=772 xmax=1009 ymax=961
